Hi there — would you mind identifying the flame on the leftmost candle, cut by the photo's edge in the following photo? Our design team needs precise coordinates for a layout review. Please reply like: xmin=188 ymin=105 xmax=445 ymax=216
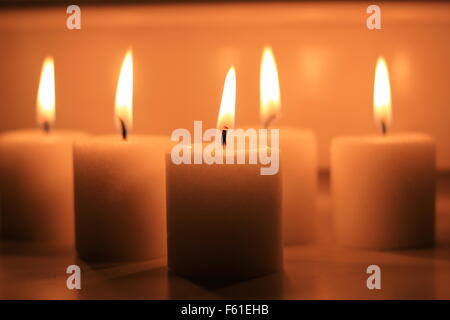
xmin=36 ymin=57 xmax=55 ymax=131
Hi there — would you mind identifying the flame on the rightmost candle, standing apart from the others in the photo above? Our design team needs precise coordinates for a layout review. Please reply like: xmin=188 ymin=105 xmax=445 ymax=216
xmin=373 ymin=57 xmax=392 ymax=133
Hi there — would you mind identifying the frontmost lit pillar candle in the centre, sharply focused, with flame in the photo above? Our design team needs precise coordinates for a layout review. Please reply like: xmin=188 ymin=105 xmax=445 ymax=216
xmin=166 ymin=68 xmax=282 ymax=280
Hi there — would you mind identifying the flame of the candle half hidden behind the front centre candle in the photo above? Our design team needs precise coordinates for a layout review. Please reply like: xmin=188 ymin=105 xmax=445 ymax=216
xmin=259 ymin=46 xmax=280 ymax=128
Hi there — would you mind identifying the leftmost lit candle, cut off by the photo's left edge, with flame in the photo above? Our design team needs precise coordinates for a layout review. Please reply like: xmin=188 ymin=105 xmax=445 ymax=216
xmin=0 ymin=57 xmax=82 ymax=247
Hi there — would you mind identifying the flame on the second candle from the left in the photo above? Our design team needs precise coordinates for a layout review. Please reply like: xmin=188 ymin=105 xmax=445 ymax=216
xmin=115 ymin=49 xmax=133 ymax=138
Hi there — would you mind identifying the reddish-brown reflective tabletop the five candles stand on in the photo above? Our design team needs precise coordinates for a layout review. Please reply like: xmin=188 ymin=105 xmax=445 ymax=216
xmin=0 ymin=174 xmax=450 ymax=299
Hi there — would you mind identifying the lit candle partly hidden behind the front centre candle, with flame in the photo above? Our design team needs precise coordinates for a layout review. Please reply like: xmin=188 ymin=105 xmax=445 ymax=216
xmin=260 ymin=47 xmax=317 ymax=245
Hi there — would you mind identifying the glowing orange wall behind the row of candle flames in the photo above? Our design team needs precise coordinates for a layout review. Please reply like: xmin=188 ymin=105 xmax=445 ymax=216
xmin=0 ymin=2 xmax=450 ymax=169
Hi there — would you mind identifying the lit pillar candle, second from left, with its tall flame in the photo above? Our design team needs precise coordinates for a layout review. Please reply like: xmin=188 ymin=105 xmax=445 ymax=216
xmin=74 ymin=51 xmax=168 ymax=262
